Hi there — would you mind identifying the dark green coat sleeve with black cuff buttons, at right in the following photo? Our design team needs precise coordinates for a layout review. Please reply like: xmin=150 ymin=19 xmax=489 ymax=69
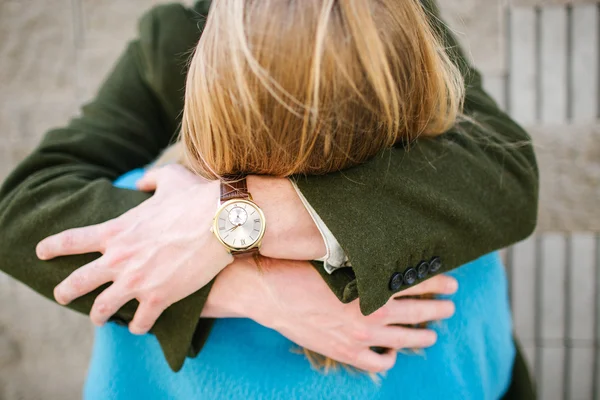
xmin=296 ymin=0 xmax=538 ymax=314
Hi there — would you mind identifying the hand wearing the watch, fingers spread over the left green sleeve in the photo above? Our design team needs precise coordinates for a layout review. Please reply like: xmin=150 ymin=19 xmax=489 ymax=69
xmin=36 ymin=165 xmax=233 ymax=334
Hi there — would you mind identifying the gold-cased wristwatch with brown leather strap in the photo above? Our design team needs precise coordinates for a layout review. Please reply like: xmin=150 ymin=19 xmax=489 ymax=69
xmin=211 ymin=178 xmax=266 ymax=255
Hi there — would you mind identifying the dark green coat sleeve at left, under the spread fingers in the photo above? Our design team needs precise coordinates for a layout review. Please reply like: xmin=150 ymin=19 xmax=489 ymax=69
xmin=0 ymin=6 xmax=211 ymax=370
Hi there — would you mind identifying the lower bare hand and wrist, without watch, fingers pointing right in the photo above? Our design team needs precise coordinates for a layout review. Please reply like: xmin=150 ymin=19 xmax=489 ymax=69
xmin=202 ymin=259 xmax=458 ymax=372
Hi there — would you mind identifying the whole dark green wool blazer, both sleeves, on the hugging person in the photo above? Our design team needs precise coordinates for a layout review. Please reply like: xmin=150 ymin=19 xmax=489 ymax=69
xmin=0 ymin=0 xmax=538 ymax=370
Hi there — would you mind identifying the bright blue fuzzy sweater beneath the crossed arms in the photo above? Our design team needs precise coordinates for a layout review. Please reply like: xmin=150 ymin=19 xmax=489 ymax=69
xmin=84 ymin=170 xmax=515 ymax=400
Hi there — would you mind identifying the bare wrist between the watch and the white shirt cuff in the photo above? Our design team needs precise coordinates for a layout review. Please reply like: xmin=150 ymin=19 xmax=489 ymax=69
xmin=247 ymin=175 xmax=326 ymax=260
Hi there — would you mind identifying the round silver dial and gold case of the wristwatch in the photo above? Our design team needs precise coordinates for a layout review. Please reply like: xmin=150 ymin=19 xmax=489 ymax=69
xmin=213 ymin=200 xmax=265 ymax=250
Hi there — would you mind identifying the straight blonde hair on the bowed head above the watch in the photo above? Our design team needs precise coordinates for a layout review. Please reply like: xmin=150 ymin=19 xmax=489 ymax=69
xmin=172 ymin=0 xmax=464 ymax=179
